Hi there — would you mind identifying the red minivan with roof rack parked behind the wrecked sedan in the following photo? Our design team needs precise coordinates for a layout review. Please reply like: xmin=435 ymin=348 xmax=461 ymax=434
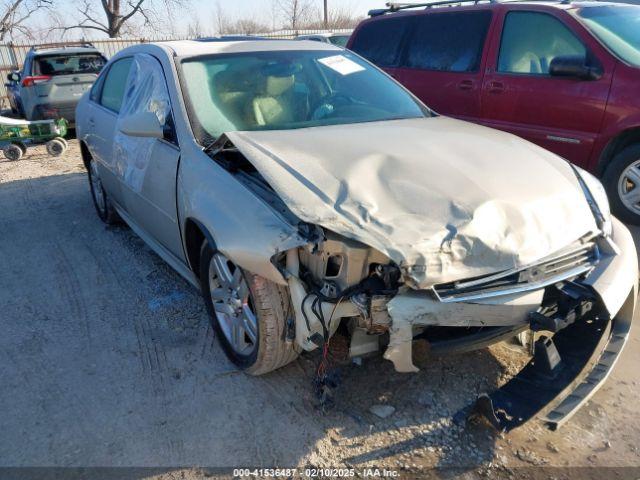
xmin=347 ymin=0 xmax=640 ymax=224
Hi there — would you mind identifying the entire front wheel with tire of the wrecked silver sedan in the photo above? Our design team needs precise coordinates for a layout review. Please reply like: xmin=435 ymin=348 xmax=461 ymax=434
xmin=200 ymin=241 xmax=298 ymax=375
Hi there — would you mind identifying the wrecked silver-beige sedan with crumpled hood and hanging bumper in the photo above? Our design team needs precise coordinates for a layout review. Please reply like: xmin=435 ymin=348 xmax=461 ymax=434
xmin=77 ymin=41 xmax=638 ymax=430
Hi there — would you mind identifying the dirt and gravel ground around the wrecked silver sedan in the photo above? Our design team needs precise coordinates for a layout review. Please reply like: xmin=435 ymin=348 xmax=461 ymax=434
xmin=0 ymin=142 xmax=640 ymax=478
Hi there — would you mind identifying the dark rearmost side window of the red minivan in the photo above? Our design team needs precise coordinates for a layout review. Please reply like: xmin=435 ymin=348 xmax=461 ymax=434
xmin=351 ymin=16 xmax=410 ymax=67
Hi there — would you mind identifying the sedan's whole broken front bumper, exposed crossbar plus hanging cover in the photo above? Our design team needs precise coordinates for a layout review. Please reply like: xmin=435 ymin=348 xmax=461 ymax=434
xmin=385 ymin=219 xmax=640 ymax=431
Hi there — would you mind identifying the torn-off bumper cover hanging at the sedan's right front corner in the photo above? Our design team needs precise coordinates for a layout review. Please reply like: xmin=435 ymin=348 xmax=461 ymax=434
xmin=471 ymin=219 xmax=640 ymax=431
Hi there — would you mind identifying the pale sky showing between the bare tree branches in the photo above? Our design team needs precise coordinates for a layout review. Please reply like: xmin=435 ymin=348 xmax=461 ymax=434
xmin=25 ymin=0 xmax=396 ymax=40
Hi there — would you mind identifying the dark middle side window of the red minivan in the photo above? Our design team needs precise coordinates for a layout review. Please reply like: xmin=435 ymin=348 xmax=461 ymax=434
xmin=405 ymin=11 xmax=491 ymax=72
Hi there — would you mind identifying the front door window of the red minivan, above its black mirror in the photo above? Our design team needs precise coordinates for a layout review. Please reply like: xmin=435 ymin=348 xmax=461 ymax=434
xmin=498 ymin=12 xmax=587 ymax=75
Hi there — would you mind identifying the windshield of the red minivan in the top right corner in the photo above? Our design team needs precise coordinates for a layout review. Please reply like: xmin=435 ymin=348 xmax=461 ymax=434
xmin=576 ymin=6 xmax=640 ymax=67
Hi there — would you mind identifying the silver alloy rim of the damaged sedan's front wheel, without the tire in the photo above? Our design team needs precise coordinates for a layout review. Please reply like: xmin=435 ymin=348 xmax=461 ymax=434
xmin=209 ymin=253 xmax=258 ymax=356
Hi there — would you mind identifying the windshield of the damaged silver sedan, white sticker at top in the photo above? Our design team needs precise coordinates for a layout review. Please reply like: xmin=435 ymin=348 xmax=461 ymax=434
xmin=182 ymin=50 xmax=429 ymax=144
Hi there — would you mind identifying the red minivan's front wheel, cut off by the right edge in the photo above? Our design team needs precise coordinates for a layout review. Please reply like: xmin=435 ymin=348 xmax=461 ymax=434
xmin=602 ymin=145 xmax=640 ymax=225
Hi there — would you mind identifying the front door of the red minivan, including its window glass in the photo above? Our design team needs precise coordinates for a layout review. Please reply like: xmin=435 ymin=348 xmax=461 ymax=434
xmin=482 ymin=7 xmax=614 ymax=165
